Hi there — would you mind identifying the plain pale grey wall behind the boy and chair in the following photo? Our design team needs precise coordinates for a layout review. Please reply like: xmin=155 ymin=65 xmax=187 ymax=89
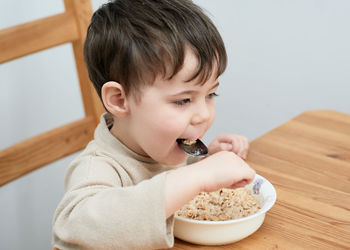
xmin=0 ymin=0 xmax=350 ymax=250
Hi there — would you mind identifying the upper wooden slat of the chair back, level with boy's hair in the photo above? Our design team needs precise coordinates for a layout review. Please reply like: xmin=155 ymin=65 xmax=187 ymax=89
xmin=0 ymin=11 xmax=79 ymax=63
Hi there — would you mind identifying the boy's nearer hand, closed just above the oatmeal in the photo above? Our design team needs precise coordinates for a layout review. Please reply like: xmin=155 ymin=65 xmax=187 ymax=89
xmin=195 ymin=151 xmax=255 ymax=192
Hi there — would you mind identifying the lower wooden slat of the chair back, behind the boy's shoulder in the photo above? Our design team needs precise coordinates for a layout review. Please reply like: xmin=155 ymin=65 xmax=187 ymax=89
xmin=0 ymin=117 xmax=96 ymax=186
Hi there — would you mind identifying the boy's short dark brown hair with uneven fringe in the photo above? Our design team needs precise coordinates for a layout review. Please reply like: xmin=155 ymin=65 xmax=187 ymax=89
xmin=84 ymin=0 xmax=227 ymax=97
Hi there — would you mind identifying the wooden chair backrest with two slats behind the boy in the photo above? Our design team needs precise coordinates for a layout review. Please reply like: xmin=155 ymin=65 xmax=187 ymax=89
xmin=0 ymin=0 xmax=104 ymax=186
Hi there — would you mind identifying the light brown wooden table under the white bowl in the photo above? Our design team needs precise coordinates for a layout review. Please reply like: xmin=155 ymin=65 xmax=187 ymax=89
xmin=174 ymin=110 xmax=350 ymax=250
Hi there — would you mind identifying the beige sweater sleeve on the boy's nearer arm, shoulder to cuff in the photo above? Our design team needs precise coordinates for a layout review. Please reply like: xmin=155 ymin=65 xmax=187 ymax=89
xmin=53 ymin=158 xmax=174 ymax=249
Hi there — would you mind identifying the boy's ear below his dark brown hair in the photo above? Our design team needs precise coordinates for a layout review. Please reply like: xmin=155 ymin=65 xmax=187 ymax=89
xmin=101 ymin=81 xmax=129 ymax=118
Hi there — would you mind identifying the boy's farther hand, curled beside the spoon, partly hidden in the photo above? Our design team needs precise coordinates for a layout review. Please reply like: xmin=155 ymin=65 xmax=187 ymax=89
xmin=208 ymin=134 xmax=249 ymax=160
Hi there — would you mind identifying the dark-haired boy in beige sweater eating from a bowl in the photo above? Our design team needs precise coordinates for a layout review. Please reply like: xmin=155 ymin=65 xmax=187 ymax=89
xmin=53 ymin=0 xmax=255 ymax=249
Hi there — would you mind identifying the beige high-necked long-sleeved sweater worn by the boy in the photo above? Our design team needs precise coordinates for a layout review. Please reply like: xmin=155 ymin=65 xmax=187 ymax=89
xmin=53 ymin=114 xmax=179 ymax=250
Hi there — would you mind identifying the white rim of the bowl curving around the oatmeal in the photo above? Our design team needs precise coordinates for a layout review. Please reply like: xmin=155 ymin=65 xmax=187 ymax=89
xmin=174 ymin=174 xmax=277 ymax=225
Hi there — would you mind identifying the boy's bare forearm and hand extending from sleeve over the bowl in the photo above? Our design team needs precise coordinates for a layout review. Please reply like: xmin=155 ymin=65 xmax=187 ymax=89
xmin=165 ymin=151 xmax=255 ymax=218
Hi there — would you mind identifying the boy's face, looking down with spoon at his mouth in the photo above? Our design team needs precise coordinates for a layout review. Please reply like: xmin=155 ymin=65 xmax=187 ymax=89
xmin=124 ymin=50 xmax=218 ymax=165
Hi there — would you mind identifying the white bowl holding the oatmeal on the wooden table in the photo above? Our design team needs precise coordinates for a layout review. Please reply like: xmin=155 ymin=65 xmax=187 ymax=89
xmin=174 ymin=174 xmax=276 ymax=245
